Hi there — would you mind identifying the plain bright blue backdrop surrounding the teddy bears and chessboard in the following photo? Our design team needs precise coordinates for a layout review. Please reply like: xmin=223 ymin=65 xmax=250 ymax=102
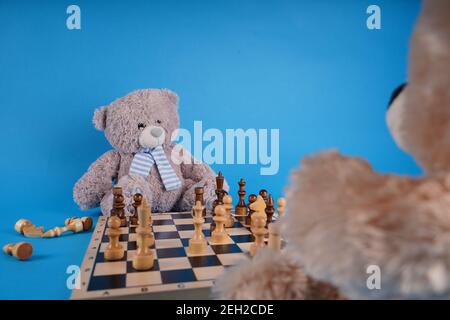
xmin=0 ymin=0 xmax=420 ymax=298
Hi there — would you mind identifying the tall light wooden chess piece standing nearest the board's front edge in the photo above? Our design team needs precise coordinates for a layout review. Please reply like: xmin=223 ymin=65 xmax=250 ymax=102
xmin=132 ymin=198 xmax=154 ymax=270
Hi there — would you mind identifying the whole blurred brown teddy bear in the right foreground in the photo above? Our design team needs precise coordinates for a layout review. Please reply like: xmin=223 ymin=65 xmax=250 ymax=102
xmin=216 ymin=0 xmax=450 ymax=299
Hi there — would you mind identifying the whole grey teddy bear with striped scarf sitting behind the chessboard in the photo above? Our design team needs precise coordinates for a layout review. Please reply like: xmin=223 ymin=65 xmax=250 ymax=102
xmin=73 ymin=89 xmax=228 ymax=215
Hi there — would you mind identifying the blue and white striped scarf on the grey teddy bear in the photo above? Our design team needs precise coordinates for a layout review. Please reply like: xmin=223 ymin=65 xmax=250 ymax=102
xmin=129 ymin=146 xmax=181 ymax=191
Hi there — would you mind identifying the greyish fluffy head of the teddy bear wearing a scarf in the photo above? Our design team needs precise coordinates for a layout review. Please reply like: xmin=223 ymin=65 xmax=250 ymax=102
xmin=93 ymin=89 xmax=180 ymax=153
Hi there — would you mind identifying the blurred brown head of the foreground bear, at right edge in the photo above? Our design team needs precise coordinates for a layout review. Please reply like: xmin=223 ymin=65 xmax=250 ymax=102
xmin=387 ymin=0 xmax=450 ymax=174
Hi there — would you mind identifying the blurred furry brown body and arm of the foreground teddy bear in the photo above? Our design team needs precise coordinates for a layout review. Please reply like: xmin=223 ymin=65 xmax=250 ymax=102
xmin=284 ymin=152 xmax=450 ymax=298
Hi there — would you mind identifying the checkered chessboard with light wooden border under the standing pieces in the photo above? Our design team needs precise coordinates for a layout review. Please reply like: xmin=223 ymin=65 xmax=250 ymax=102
xmin=71 ymin=212 xmax=264 ymax=299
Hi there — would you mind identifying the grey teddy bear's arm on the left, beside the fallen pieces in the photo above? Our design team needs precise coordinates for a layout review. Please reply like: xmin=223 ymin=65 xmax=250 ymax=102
xmin=73 ymin=150 xmax=120 ymax=210
